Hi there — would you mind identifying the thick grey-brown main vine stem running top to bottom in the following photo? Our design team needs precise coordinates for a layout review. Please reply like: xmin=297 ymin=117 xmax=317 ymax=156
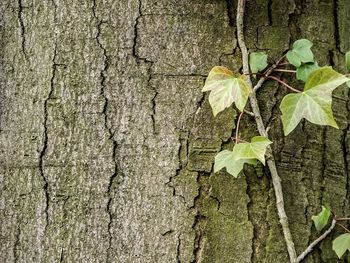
xmin=236 ymin=0 xmax=297 ymax=263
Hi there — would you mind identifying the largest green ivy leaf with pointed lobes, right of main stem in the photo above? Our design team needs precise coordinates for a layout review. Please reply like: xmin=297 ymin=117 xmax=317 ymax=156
xmin=280 ymin=67 xmax=349 ymax=135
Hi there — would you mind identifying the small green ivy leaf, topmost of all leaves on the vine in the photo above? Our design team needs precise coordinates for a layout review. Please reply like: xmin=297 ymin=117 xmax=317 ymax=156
xmin=287 ymin=39 xmax=314 ymax=68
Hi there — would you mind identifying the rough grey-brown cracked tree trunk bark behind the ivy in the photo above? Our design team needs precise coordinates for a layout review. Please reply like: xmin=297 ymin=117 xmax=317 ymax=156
xmin=0 ymin=0 xmax=350 ymax=263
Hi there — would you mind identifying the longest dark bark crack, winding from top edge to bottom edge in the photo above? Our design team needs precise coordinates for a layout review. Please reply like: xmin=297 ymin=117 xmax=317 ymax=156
xmin=92 ymin=0 xmax=118 ymax=262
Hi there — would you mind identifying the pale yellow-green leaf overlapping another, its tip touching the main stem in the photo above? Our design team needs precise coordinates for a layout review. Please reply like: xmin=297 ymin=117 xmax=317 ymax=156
xmin=234 ymin=136 xmax=272 ymax=165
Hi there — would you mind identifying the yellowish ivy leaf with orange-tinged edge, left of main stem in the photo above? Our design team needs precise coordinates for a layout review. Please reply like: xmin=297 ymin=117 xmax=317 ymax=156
xmin=202 ymin=66 xmax=252 ymax=116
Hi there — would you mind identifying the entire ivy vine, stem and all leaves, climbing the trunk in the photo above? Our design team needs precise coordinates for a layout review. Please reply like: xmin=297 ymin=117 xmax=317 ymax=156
xmin=202 ymin=0 xmax=350 ymax=263
